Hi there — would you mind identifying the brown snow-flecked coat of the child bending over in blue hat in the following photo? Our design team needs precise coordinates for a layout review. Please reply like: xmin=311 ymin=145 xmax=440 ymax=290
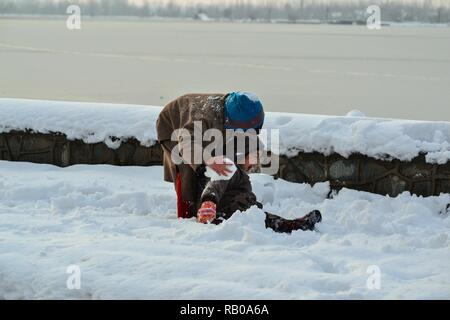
xmin=156 ymin=94 xmax=227 ymax=201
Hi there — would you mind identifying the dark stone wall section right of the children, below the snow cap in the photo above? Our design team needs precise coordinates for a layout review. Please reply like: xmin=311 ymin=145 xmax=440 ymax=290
xmin=279 ymin=153 xmax=450 ymax=196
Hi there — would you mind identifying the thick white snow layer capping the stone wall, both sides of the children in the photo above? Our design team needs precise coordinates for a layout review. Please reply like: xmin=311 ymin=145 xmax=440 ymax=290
xmin=0 ymin=98 xmax=450 ymax=164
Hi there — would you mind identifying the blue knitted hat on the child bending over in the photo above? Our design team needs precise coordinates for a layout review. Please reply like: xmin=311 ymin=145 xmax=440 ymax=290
xmin=225 ymin=92 xmax=264 ymax=131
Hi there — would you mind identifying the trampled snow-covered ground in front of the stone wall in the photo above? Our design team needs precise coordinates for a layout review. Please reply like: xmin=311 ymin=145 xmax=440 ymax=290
xmin=0 ymin=161 xmax=450 ymax=299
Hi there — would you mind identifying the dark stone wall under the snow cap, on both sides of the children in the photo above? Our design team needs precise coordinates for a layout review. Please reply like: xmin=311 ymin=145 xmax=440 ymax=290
xmin=0 ymin=131 xmax=450 ymax=196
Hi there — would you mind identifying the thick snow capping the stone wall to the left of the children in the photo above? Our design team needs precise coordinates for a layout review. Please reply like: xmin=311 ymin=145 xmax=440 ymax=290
xmin=0 ymin=98 xmax=161 ymax=149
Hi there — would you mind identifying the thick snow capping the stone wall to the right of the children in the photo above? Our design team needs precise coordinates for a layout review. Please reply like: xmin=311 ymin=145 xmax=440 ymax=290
xmin=264 ymin=113 xmax=450 ymax=164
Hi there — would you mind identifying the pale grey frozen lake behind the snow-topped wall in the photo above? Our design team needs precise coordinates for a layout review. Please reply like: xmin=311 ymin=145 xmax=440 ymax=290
xmin=0 ymin=18 xmax=450 ymax=121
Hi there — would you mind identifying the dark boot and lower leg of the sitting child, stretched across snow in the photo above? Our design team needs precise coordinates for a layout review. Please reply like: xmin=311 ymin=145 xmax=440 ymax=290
xmin=266 ymin=210 xmax=322 ymax=233
